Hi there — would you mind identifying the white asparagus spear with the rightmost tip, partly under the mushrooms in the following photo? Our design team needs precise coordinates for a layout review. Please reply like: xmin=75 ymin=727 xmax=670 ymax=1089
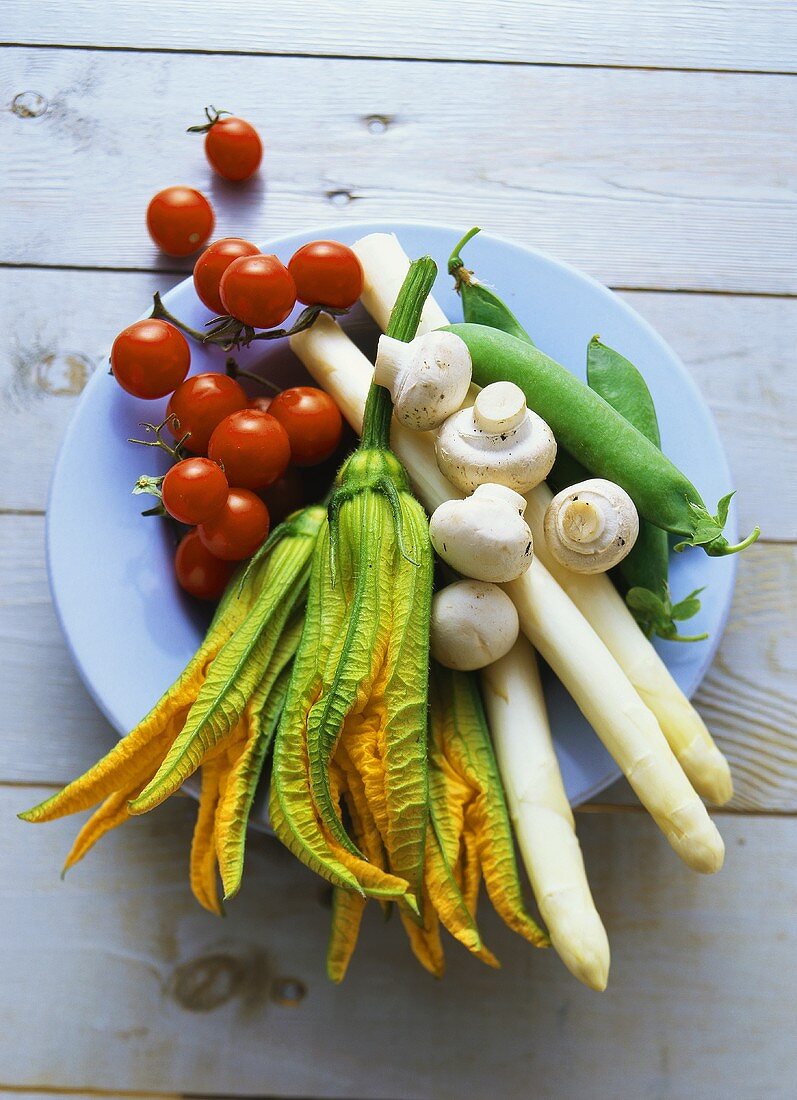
xmin=354 ymin=227 xmax=733 ymax=806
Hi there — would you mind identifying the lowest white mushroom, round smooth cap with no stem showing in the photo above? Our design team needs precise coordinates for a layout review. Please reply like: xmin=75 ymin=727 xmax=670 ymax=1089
xmin=431 ymin=581 xmax=520 ymax=672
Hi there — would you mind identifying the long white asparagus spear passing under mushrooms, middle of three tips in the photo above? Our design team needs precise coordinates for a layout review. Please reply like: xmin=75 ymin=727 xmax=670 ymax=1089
xmin=290 ymin=316 xmax=724 ymax=873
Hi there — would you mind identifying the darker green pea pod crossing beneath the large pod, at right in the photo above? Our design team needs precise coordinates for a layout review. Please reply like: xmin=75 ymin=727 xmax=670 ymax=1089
xmin=584 ymin=337 xmax=708 ymax=641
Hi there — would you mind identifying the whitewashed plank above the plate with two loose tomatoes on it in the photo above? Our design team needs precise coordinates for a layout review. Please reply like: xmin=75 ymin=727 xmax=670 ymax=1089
xmin=0 ymin=50 xmax=797 ymax=294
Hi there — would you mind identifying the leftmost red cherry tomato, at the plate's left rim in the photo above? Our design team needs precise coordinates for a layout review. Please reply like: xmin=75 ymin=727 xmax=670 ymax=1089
xmin=111 ymin=318 xmax=191 ymax=400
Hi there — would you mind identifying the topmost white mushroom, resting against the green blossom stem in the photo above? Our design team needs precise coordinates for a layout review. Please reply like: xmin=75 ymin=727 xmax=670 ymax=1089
xmin=374 ymin=332 xmax=472 ymax=431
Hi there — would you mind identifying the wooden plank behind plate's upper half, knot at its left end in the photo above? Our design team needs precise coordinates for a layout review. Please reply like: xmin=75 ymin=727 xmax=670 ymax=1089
xmin=0 ymin=272 xmax=797 ymax=541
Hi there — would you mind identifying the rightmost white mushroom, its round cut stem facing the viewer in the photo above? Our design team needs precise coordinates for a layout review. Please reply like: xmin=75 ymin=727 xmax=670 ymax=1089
xmin=544 ymin=477 xmax=640 ymax=573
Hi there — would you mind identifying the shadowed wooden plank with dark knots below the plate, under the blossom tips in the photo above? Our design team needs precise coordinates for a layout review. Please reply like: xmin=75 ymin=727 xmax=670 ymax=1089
xmin=0 ymin=790 xmax=797 ymax=1100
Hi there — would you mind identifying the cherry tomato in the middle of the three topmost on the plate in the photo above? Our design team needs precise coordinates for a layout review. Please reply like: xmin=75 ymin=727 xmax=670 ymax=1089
xmin=219 ymin=256 xmax=296 ymax=329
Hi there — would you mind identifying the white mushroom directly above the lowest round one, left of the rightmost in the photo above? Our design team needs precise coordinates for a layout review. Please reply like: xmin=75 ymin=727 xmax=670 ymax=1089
xmin=429 ymin=483 xmax=533 ymax=584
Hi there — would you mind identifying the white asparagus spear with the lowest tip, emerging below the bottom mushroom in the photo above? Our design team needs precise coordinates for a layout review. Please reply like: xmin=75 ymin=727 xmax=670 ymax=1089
xmin=480 ymin=635 xmax=609 ymax=990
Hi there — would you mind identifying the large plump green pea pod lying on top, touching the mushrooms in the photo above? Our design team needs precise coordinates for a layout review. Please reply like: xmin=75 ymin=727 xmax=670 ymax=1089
xmin=449 ymin=323 xmax=761 ymax=557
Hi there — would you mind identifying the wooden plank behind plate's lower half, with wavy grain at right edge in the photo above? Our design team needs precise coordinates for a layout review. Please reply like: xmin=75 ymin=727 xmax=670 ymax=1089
xmin=0 ymin=516 xmax=797 ymax=811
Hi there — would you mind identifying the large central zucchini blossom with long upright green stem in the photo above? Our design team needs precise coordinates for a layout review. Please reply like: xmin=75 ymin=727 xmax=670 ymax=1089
xmin=273 ymin=257 xmax=436 ymax=910
